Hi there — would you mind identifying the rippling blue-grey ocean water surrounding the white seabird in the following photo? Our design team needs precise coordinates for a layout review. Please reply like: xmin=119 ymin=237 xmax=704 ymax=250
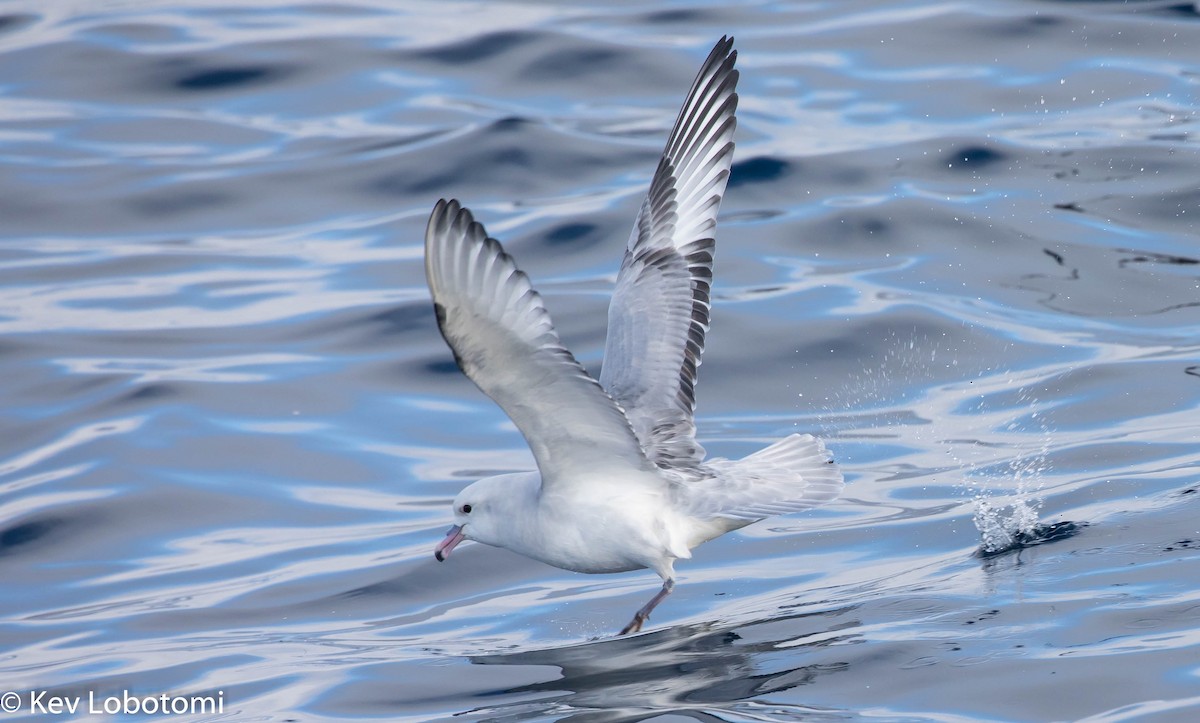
xmin=0 ymin=0 xmax=1200 ymax=722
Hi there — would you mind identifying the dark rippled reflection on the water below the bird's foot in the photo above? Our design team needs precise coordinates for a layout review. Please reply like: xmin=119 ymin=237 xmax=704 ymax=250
xmin=463 ymin=607 xmax=859 ymax=723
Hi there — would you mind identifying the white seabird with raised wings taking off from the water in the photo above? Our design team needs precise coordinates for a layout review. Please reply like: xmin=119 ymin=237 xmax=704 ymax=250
xmin=425 ymin=37 xmax=842 ymax=634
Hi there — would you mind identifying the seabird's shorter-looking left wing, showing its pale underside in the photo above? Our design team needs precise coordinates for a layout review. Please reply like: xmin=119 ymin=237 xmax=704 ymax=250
xmin=425 ymin=199 xmax=650 ymax=484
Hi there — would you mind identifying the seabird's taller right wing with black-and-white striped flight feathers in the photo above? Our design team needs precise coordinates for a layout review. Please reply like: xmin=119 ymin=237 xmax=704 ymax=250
xmin=600 ymin=37 xmax=738 ymax=467
